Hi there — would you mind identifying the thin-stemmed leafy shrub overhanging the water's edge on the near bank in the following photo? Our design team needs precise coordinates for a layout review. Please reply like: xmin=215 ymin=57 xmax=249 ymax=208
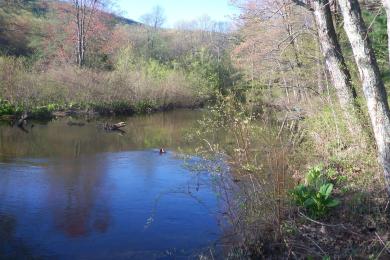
xmin=188 ymin=96 xmax=293 ymax=259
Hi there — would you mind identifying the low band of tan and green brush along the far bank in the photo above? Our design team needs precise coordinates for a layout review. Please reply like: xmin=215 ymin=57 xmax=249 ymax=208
xmin=0 ymin=57 xmax=211 ymax=116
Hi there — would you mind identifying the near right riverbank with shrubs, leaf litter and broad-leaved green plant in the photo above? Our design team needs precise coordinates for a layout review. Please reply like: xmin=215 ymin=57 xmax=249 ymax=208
xmin=187 ymin=97 xmax=390 ymax=259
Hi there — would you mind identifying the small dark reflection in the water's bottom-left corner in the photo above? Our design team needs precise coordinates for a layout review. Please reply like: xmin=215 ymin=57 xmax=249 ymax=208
xmin=0 ymin=213 xmax=33 ymax=259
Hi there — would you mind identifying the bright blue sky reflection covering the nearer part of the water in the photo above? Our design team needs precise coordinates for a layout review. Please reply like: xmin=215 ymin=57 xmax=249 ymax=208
xmin=0 ymin=151 xmax=220 ymax=257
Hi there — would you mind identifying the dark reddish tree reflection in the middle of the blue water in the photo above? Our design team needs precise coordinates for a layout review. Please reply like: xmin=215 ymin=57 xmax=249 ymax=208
xmin=49 ymin=157 xmax=110 ymax=237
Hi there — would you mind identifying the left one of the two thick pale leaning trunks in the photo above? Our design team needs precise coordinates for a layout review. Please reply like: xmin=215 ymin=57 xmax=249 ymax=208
xmin=313 ymin=0 xmax=363 ymax=138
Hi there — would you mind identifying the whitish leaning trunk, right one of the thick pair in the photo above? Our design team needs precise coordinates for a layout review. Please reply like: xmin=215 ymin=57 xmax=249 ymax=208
xmin=339 ymin=0 xmax=390 ymax=194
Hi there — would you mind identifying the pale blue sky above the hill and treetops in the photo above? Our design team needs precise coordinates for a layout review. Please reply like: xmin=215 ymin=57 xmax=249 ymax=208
xmin=116 ymin=0 xmax=237 ymax=27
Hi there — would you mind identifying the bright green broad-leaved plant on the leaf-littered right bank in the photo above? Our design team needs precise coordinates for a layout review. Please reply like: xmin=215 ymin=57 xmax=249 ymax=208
xmin=290 ymin=166 xmax=340 ymax=218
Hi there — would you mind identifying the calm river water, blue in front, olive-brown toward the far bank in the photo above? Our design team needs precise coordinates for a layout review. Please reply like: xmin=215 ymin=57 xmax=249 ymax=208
xmin=0 ymin=110 xmax=227 ymax=259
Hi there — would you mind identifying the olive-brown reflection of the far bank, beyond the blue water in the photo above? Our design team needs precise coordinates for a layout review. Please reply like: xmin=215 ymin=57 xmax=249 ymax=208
xmin=0 ymin=110 xmax=201 ymax=158
